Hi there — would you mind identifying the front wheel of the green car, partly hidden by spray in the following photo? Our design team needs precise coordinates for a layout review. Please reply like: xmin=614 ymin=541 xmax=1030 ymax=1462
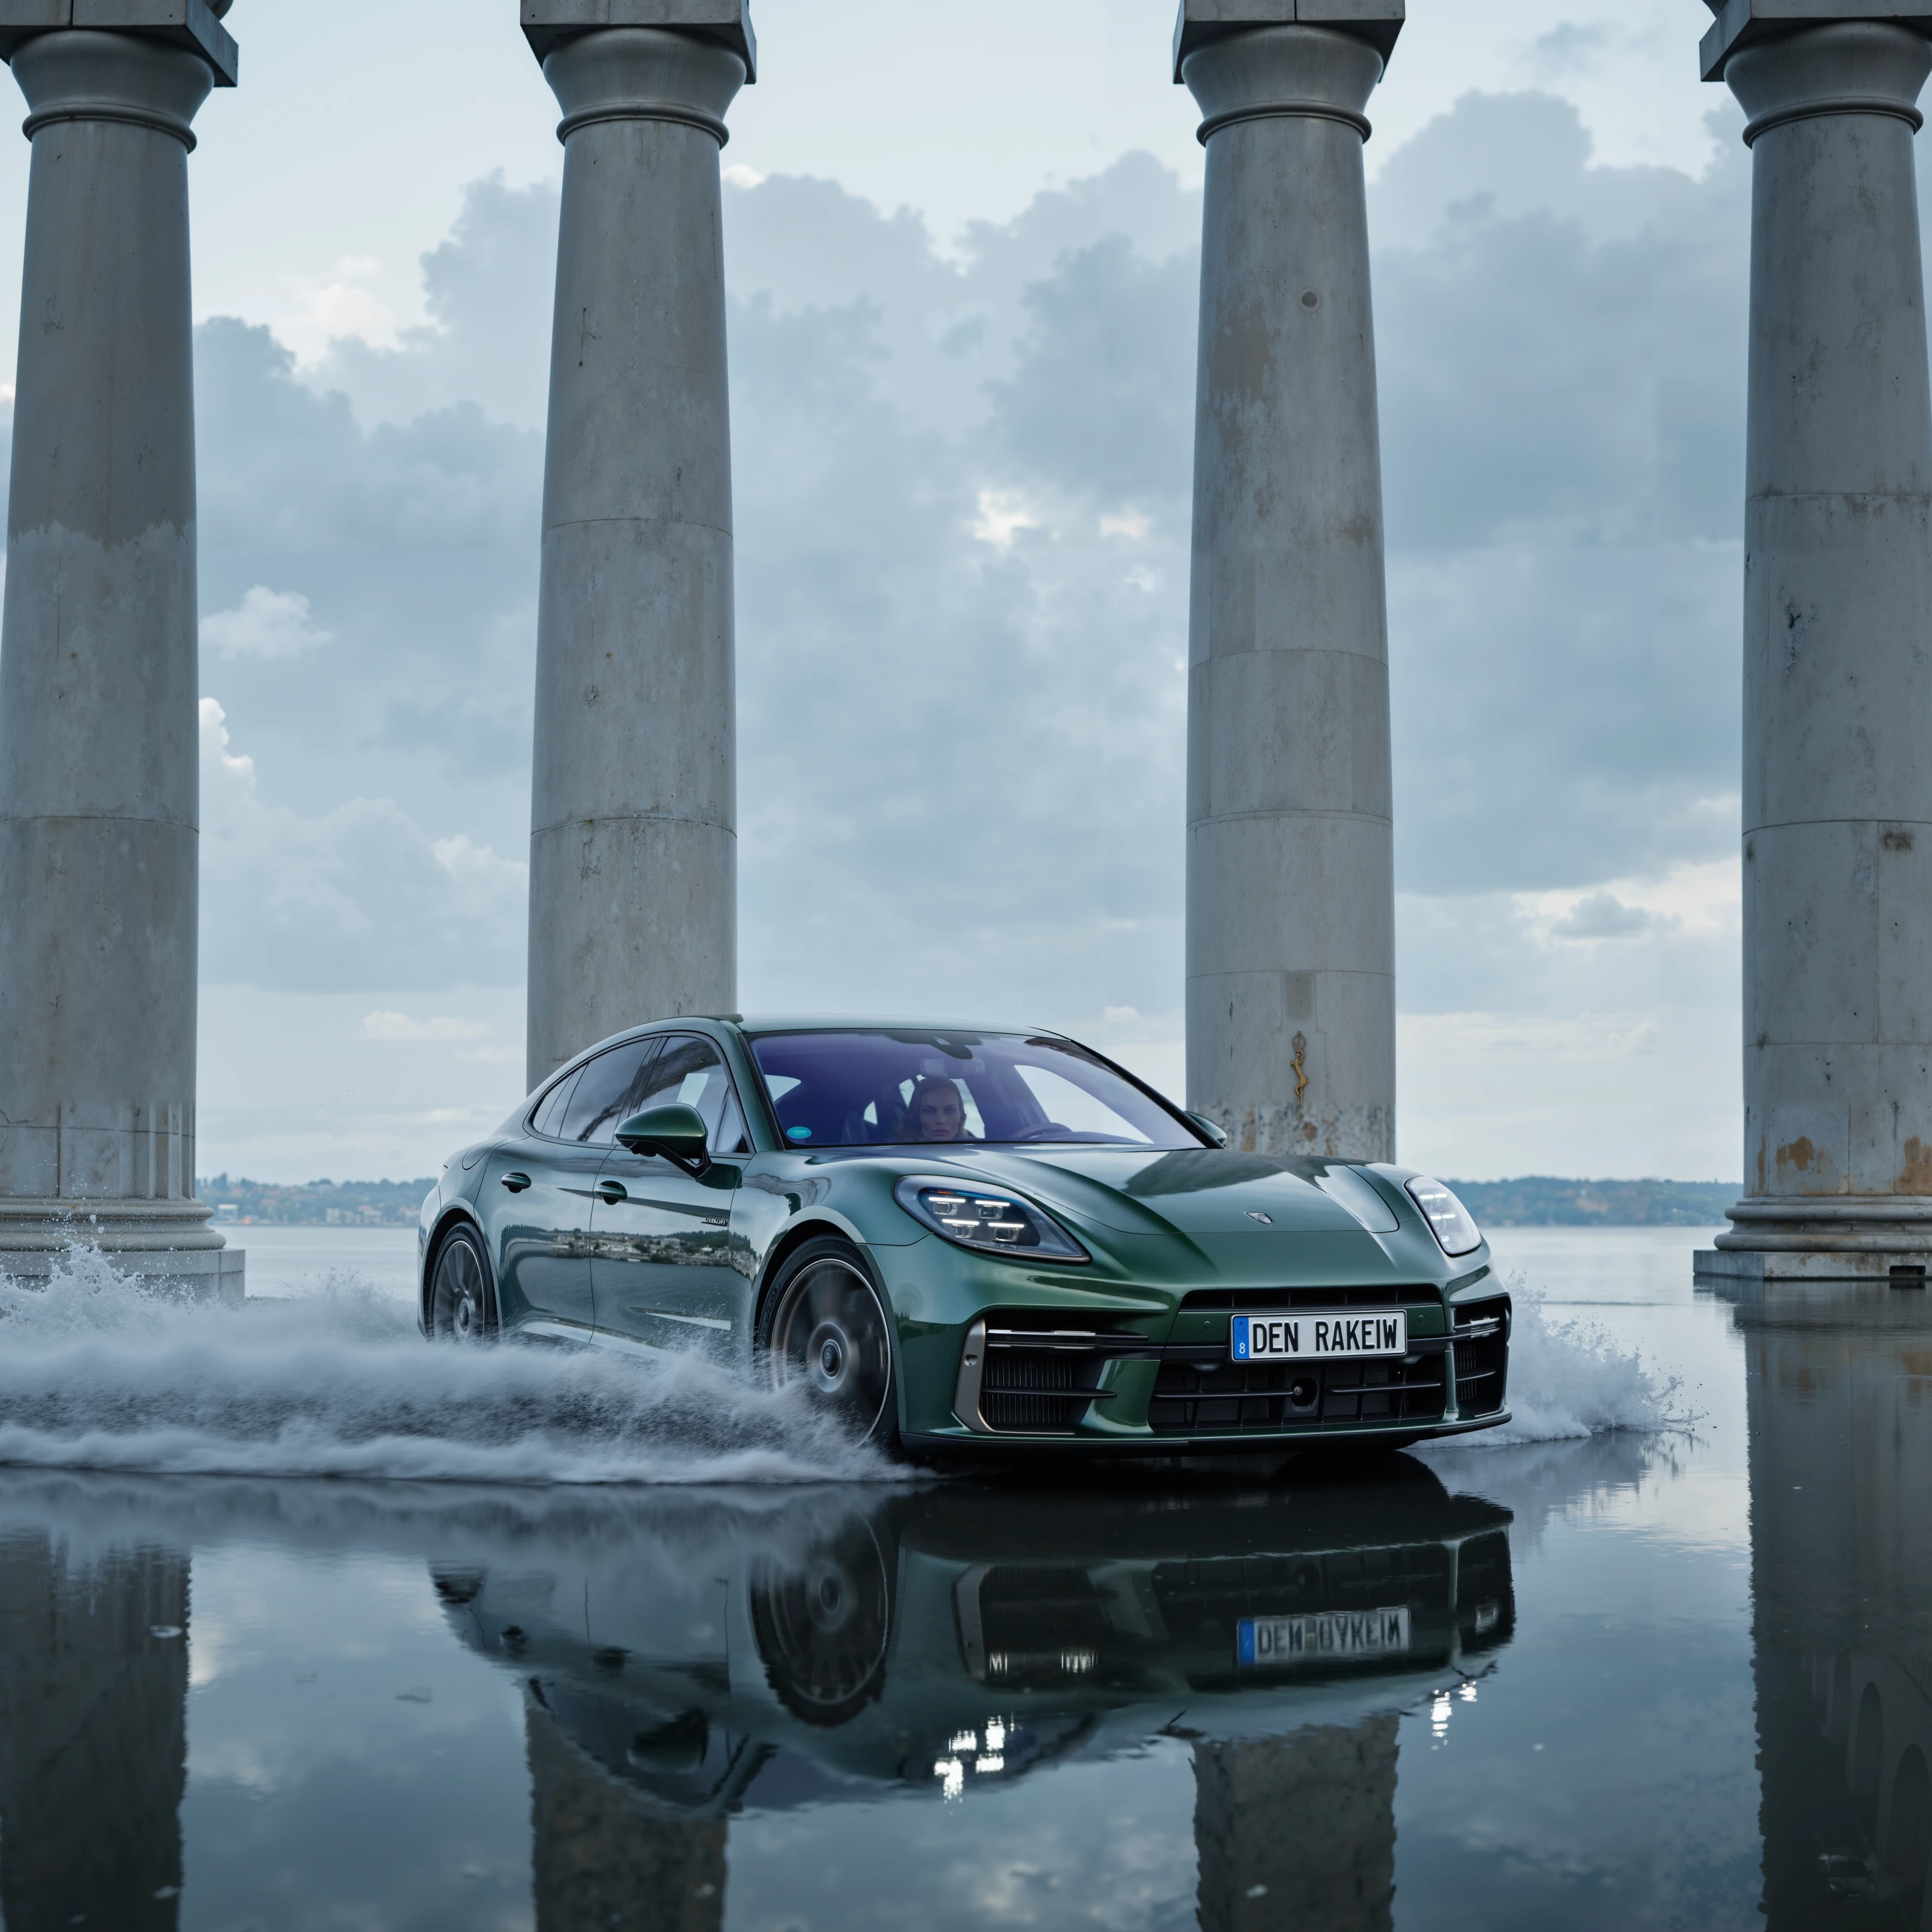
xmin=757 ymin=1234 xmax=899 ymax=1451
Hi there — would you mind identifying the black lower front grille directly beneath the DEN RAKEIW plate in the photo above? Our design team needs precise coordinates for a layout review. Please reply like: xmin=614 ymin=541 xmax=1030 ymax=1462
xmin=1148 ymin=1350 xmax=1445 ymax=1436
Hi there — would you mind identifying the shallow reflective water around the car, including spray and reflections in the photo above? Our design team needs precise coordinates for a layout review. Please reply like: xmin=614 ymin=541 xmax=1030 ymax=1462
xmin=0 ymin=1229 xmax=1932 ymax=1932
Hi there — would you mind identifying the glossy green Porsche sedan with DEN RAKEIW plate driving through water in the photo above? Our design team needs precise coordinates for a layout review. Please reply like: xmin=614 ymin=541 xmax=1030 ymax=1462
xmin=419 ymin=1016 xmax=1511 ymax=1457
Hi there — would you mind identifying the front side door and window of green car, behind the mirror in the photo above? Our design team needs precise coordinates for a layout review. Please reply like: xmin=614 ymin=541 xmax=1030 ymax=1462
xmin=591 ymin=1033 xmax=751 ymax=1360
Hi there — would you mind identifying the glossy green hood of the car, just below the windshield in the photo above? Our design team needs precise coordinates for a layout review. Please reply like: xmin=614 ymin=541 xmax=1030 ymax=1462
xmin=931 ymin=1148 xmax=1395 ymax=1238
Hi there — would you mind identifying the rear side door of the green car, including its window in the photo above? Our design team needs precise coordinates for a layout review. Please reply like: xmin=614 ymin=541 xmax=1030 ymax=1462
xmin=481 ymin=1036 xmax=657 ymax=1333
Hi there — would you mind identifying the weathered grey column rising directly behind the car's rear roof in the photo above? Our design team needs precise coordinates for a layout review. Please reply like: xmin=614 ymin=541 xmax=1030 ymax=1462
xmin=523 ymin=0 xmax=757 ymax=1086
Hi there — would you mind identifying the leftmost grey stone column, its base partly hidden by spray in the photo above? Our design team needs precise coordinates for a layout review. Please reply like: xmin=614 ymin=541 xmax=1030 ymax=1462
xmin=0 ymin=0 xmax=242 ymax=1296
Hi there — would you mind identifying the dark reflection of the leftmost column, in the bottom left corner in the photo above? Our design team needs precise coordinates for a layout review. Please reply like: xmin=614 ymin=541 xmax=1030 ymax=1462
xmin=0 ymin=1532 xmax=188 ymax=1932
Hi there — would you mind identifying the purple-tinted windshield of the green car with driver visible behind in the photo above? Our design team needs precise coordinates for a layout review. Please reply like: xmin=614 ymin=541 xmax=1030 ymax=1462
xmin=751 ymin=1026 xmax=1202 ymax=1148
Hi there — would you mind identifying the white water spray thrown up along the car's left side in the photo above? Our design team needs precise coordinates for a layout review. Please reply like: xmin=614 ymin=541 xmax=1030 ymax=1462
xmin=0 ymin=1246 xmax=902 ymax=1484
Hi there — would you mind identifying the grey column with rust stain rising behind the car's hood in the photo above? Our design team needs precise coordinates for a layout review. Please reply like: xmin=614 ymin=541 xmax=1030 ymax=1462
xmin=1175 ymin=0 xmax=1403 ymax=1161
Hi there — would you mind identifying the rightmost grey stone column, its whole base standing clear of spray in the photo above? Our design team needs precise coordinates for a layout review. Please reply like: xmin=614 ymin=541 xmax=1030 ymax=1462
xmin=1698 ymin=15 xmax=1932 ymax=1277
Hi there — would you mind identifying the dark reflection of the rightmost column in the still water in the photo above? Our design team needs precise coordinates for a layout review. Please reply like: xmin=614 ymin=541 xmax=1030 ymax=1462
xmin=1733 ymin=1285 xmax=1932 ymax=1932
